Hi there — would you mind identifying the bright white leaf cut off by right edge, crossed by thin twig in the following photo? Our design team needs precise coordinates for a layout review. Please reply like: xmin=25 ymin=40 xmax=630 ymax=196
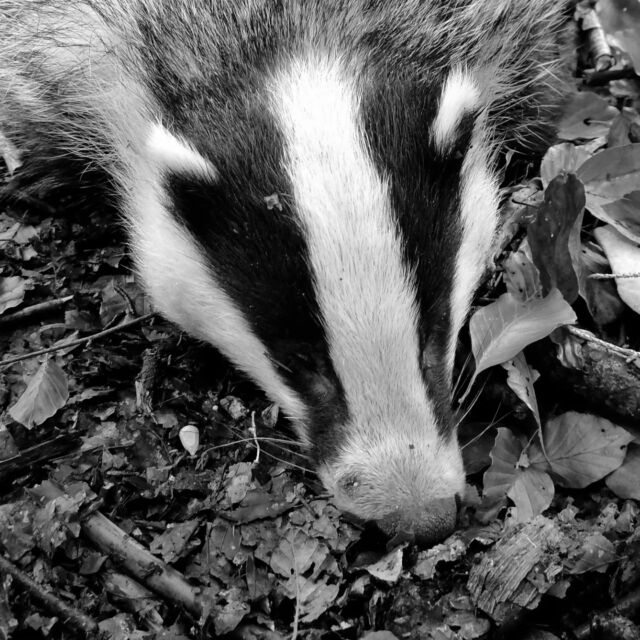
xmin=593 ymin=225 xmax=640 ymax=313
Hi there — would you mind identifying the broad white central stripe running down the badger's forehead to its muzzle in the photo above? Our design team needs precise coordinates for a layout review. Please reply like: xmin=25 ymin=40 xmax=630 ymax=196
xmin=273 ymin=59 xmax=437 ymax=456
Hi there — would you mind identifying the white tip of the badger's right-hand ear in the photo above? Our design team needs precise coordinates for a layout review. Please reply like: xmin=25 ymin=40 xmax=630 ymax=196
xmin=431 ymin=69 xmax=480 ymax=151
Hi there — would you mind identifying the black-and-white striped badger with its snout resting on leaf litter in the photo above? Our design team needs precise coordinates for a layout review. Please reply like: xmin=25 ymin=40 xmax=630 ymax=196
xmin=0 ymin=0 xmax=561 ymax=540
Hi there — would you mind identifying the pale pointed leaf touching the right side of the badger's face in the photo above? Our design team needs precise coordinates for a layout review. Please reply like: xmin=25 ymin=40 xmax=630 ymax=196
xmin=469 ymin=289 xmax=576 ymax=387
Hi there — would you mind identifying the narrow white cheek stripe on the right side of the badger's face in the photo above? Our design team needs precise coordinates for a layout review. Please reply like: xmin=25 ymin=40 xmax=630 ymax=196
xmin=448 ymin=120 xmax=498 ymax=373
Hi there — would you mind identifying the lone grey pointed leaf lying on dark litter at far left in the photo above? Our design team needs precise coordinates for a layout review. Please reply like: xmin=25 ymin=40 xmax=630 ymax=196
xmin=9 ymin=359 xmax=69 ymax=429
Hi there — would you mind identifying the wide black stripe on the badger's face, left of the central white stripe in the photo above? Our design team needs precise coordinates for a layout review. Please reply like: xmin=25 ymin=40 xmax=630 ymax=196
xmin=164 ymin=166 xmax=347 ymax=460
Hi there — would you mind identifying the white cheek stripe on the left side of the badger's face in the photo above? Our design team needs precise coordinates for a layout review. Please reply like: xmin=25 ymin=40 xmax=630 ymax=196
xmin=128 ymin=148 xmax=306 ymax=432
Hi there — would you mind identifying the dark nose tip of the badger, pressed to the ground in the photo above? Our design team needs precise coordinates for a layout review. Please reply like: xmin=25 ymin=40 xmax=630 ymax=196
xmin=376 ymin=497 xmax=458 ymax=546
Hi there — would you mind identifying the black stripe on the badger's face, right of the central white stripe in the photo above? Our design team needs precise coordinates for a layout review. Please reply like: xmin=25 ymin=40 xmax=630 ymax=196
xmin=362 ymin=75 xmax=475 ymax=435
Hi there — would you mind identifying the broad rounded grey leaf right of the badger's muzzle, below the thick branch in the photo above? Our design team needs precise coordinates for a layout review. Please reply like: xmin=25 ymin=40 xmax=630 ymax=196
xmin=529 ymin=411 xmax=633 ymax=489
